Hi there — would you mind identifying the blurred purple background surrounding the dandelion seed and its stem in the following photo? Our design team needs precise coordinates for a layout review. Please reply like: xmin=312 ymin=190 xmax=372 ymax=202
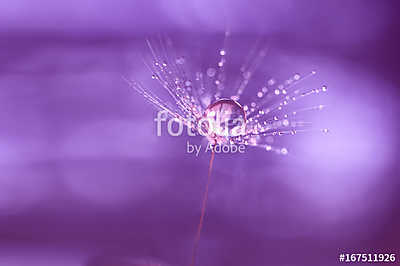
xmin=0 ymin=0 xmax=400 ymax=266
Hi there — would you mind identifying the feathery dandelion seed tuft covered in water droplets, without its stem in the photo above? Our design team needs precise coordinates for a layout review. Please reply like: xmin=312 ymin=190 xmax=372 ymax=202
xmin=128 ymin=33 xmax=328 ymax=155
